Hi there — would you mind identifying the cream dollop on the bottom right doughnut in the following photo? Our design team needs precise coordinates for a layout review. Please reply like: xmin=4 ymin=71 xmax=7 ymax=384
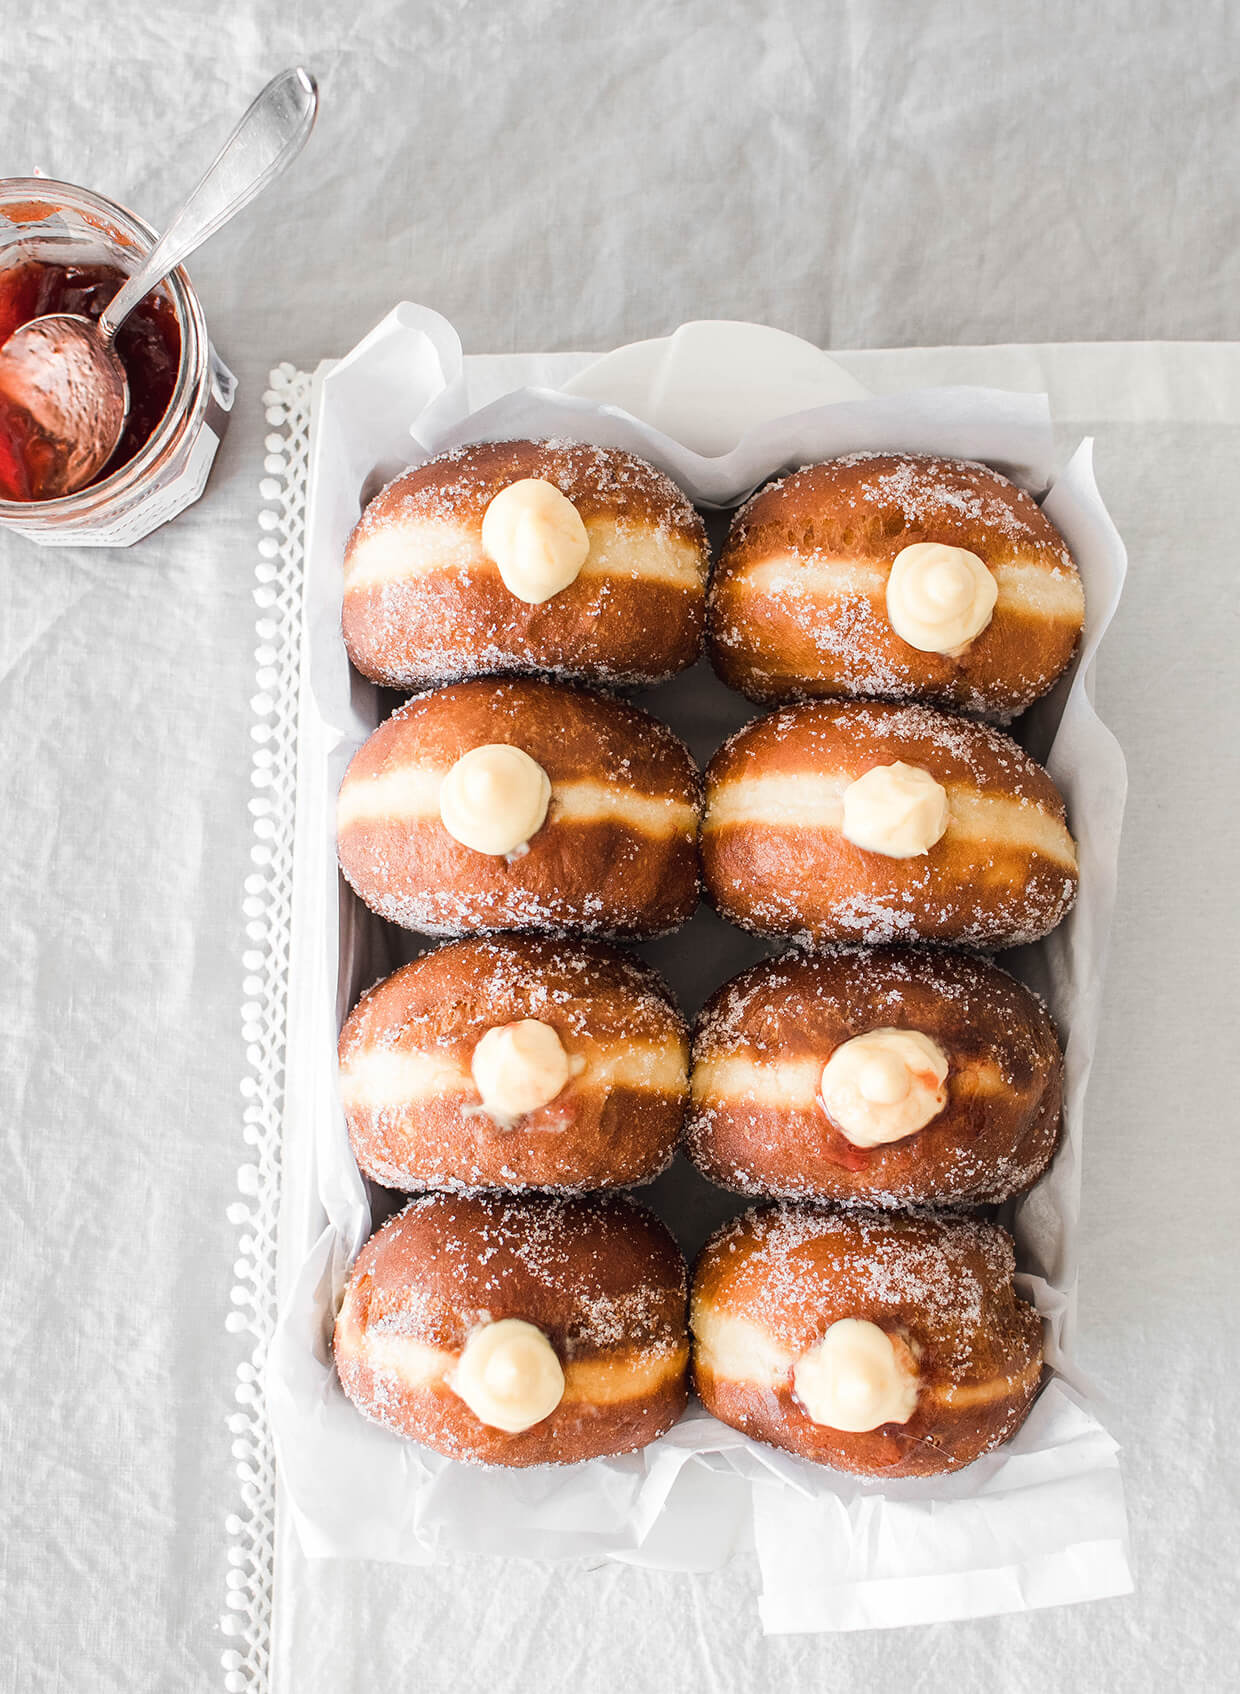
xmin=793 ymin=1318 xmax=918 ymax=1433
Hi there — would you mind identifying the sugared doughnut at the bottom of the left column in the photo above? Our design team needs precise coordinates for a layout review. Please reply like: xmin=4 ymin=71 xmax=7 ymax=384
xmin=334 ymin=1194 xmax=689 ymax=1467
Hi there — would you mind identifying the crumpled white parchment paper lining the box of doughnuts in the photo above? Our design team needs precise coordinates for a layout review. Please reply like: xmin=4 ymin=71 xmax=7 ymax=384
xmin=268 ymin=305 xmax=1130 ymax=1630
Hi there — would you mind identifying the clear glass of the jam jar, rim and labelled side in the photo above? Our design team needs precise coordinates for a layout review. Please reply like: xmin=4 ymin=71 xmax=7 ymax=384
xmin=0 ymin=176 xmax=235 ymax=547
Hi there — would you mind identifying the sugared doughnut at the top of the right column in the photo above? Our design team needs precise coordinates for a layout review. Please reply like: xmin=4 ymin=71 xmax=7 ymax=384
xmin=708 ymin=452 xmax=1084 ymax=718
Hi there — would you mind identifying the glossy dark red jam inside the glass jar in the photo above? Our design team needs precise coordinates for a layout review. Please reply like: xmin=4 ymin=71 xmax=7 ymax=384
xmin=0 ymin=259 xmax=181 ymax=500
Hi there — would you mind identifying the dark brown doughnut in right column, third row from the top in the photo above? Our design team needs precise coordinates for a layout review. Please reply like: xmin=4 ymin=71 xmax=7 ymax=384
xmin=686 ymin=947 xmax=1064 ymax=1206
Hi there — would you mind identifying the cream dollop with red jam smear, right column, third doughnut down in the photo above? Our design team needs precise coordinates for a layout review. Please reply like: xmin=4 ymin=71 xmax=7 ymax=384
xmin=820 ymin=1028 xmax=947 ymax=1147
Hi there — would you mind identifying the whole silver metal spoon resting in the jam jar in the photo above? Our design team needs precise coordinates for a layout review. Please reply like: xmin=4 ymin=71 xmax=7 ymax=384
xmin=0 ymin=66 xmax=318 ymax=500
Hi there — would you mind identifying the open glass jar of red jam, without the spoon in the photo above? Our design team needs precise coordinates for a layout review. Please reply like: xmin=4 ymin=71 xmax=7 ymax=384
xmin=0 ymin=176 xmax=235 ymax=547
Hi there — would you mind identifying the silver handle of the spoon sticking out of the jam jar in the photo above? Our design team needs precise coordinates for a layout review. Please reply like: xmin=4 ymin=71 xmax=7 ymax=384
xmin=98 ymin=66 xmax=318 ymax=344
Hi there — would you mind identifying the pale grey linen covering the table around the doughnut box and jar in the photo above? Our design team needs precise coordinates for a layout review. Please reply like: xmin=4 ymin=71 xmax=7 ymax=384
xmin=0 ymin=0 xmax=1240 ymax=1694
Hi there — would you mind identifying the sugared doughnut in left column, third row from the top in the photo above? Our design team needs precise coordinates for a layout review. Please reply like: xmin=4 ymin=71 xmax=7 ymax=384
xmin=340 ymin=935 xmax=689 ymax=1191
